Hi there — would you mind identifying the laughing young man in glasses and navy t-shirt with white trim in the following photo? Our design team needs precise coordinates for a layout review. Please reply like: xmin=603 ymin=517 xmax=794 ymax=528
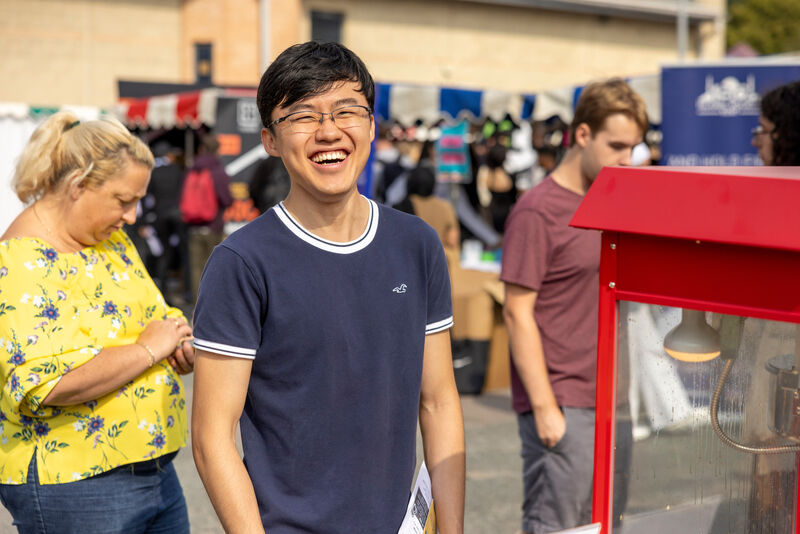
xmin=192 ymin=42 xmax=464 ymax=534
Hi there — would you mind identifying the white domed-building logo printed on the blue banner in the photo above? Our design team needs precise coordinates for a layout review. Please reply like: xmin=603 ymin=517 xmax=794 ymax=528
xmin=695 ymin=74 xmax=759 ymax=117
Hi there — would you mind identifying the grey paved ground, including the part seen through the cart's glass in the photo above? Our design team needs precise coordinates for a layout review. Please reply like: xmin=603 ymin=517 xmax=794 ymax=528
xmin=0 ymin=380 xmax=797 ymax=534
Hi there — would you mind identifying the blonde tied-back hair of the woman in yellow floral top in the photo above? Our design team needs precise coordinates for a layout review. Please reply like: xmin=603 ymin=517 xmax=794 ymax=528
xmin=11 ymin=111 xmax=153 ymax=204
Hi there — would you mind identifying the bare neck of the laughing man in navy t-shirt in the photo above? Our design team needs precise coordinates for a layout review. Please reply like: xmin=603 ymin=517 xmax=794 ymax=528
xmin=283 ymin=190 xmax=370 ymax=243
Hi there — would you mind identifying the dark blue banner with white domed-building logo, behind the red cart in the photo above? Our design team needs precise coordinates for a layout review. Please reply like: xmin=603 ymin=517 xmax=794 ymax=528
xmin=661 ymin=62 xmax=800 ymax=166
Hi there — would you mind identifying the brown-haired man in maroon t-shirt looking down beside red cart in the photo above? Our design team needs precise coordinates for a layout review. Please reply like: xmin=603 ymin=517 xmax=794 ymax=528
xmin=500 ymin=79 xmax=648 ymax=534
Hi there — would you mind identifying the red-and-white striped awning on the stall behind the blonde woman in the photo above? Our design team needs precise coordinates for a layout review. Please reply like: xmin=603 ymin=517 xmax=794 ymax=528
xmin=114 ymin=87 xmax=223 ymax=128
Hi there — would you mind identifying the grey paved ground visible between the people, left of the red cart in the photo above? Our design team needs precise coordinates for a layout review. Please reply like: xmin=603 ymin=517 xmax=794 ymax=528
xmin=0 ymin=388 xmax=522 ymax=534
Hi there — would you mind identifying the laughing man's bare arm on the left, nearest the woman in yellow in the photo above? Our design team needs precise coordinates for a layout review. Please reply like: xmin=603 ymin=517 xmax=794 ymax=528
xmin=192 ymin=350 xmax=264 ymax=534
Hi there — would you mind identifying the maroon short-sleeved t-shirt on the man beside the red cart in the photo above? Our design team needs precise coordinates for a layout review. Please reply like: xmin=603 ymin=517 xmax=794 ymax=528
xmin=500 ymin=176 xmax=600 ymax=413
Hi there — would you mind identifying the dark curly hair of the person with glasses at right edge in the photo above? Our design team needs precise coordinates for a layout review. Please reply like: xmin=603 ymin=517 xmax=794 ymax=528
xmin=761 ymin=81 xmax=800 ymax=165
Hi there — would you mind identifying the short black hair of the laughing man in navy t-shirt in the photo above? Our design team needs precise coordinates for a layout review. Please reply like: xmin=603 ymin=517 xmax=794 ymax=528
xmin=256 ymin=41 xmax=375 ymax=127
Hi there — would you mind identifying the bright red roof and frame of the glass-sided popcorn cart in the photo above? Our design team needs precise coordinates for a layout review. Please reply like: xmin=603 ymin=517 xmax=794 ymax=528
xmin=571 ymin=167 xmax=800 ymax=534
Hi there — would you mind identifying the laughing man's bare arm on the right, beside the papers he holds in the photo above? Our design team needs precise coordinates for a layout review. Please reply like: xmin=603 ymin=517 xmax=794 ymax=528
xmin=419 ymin=331 xmax=465 ymax=534
